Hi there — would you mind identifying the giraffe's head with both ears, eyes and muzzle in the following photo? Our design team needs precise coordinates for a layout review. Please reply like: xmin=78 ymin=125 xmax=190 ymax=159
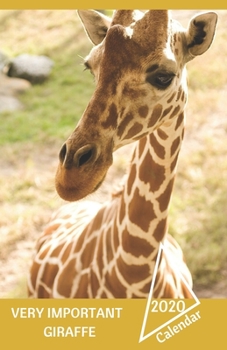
xmin=56 ymin=10 xmax=217 ymax=201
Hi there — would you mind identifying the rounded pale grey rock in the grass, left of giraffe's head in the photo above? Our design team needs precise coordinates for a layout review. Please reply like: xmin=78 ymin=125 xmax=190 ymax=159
xmin=8 ymin=54 xmax=54 ymax=84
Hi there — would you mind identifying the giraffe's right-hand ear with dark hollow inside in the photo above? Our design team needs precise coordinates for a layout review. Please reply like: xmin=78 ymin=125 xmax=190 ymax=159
xmin=186 ymin=12 xmax=217 ymax=60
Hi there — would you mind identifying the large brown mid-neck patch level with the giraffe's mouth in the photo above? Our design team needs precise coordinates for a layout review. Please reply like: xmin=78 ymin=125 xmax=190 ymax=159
xmin=139 ymin=152 xmax=165 ymax=192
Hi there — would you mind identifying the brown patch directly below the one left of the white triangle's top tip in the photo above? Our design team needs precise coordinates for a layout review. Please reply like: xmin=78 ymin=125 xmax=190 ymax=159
xmin=117 ymin=256 xmax=150 ymax=285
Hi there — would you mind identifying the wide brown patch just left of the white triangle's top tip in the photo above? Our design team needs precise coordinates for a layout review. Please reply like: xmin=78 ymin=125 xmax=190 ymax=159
xmin=122 ymin=229 xmax=154 ymax=258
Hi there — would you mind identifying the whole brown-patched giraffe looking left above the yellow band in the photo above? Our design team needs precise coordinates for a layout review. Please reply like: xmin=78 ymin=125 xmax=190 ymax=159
xmin=28 ymin=10 xmax=217 ymax=298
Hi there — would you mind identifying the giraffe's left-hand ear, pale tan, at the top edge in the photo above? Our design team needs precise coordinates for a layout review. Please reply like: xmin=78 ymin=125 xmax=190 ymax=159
xmin=77 ymin=10 xmax=111 ymax=45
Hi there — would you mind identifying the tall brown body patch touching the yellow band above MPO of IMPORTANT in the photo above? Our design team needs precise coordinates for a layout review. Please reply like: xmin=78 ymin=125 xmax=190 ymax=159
xmin=57 ymin=258 xmax=77 ymax=298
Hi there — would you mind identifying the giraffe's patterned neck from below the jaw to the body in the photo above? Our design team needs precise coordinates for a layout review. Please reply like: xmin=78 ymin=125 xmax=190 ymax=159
xmin=118 ymin=112 xmax=184 ymax=264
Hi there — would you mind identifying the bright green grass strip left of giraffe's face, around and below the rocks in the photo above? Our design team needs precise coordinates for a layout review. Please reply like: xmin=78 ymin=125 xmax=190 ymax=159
xmin=0 ymin=49 xmax=93 ymax=145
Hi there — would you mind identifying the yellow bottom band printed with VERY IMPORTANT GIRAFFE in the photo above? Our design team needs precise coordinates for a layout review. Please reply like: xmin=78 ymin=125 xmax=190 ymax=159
xmin=0 ymin=299 xmax=227 ymax=350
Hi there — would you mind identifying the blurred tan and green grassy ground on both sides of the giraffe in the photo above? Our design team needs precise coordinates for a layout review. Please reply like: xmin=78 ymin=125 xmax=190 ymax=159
xmin=0 ymin=10 xmax=227 ymax=297
